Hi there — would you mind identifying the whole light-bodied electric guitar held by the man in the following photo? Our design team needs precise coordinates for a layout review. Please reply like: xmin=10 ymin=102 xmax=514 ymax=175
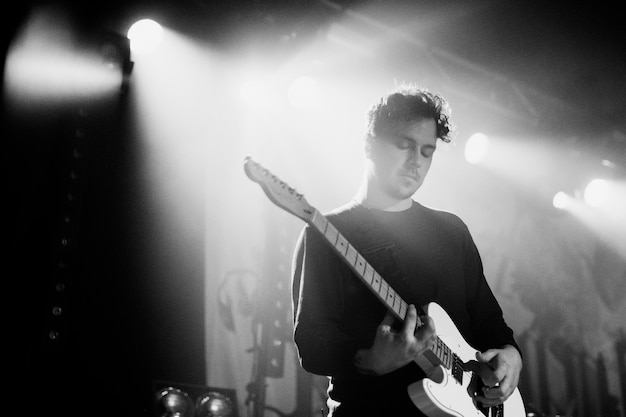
xmin=244 ymin=157 xmax=526 ymax=417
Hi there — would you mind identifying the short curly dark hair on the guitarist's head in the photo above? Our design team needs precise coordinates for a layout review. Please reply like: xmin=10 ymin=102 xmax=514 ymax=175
xmin=365 ymin=84 xmax=454 ymax=147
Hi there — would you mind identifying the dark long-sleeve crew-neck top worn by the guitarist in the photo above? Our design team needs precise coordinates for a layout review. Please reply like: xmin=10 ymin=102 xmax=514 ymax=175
xmin=292 ymin=202 xmax=517 ymax=416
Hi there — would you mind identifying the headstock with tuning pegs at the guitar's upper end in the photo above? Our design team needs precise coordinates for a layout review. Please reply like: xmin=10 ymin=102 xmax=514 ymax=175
xmin=243 ymin=156 xmax=315 ymax=223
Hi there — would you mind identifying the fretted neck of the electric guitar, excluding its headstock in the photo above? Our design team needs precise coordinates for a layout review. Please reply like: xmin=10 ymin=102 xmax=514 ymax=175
xmin=308 ymin=209 xmax=460 ymax=377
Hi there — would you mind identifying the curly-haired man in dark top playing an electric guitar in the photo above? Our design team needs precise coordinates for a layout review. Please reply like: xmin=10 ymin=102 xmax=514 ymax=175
xmin=293 ymin=85 xmax=522 ymax=417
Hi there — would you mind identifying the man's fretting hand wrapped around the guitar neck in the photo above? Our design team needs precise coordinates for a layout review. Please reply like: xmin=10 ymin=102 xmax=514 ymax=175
xmin=354 ymin=305 xmax=437 ymax=375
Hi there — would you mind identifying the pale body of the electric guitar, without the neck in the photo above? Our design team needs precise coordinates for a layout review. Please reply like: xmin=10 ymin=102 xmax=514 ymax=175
xmin=407 ymin=303 xmax=526 ymax=417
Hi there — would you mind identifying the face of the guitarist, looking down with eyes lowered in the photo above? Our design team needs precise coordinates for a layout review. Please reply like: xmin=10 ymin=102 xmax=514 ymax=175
xmin=369 ymin=119 xmax=437 ymax=201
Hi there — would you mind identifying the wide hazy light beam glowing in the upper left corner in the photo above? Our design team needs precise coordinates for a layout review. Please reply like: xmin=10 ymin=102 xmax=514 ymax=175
xmin=4 ymin=10 xmax=132 ymax=101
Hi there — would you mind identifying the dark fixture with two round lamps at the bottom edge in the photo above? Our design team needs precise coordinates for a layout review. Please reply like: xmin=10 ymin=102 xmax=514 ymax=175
xmin=152 ymin=381 xmax=239 ymax=417
